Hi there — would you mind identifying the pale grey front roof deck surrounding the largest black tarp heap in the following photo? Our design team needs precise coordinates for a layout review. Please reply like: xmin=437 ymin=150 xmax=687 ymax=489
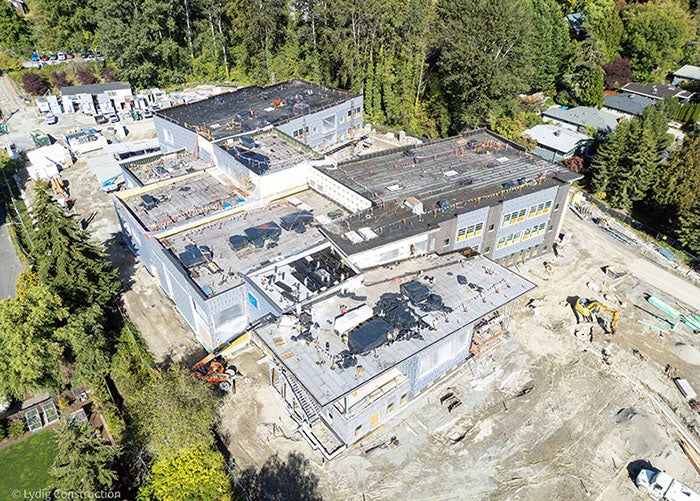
xmin=256 ymin=254 xmax=535 ymax=406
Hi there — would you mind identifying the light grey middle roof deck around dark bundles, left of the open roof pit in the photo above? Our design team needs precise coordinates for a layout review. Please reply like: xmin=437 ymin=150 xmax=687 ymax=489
xmin=161 ymin=190 xmax=350 ymax=295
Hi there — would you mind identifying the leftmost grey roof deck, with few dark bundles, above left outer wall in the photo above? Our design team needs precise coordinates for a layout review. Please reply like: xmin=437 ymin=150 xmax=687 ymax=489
xmin=123 ymin=169 xmax=244 ymax=231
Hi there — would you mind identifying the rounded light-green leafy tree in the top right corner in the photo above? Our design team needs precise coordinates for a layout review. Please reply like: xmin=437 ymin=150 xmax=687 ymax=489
xmin=622 ymin=0 xmax=697 ymax=81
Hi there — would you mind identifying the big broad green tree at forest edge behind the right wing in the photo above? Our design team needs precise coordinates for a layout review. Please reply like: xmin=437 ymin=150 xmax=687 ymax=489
xmin=435 ymin=0 xmax=532 ymax=132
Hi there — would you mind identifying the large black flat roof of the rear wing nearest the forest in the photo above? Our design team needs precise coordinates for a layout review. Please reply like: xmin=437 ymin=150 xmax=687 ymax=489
xmin=156 ymin=79 xmax=357 ymax=140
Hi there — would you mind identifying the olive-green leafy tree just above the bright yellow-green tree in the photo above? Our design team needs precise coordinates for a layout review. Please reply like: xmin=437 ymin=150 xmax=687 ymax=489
xmin=127 ymin=366 xmax=217 ymax=459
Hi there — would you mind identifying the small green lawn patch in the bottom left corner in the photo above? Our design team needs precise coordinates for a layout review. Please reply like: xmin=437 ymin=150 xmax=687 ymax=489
xmin=0 ymin=430 xmax=56 ymax=499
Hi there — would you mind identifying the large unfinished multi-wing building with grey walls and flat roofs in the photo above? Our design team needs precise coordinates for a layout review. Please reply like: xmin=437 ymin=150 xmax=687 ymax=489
xmin=114 ymin=84 xmax=578 ymax=457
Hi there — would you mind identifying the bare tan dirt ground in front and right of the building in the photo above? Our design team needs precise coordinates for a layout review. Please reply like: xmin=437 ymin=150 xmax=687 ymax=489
xmin=216 ymin=214 xmax=700 ymax=501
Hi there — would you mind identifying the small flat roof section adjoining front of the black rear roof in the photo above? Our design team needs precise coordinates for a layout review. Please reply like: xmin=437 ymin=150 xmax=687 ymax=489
xmin=219 ymin=130 xmax=319 ymax=174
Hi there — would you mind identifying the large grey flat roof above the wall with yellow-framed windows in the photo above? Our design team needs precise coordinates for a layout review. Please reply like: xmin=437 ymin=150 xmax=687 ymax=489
xmin=315 ymin=129 xmax=581 ymax=254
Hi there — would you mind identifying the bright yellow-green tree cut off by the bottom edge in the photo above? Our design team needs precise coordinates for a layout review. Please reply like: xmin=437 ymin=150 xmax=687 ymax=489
xmin=137 ymin=444 xmax=232 ymax=501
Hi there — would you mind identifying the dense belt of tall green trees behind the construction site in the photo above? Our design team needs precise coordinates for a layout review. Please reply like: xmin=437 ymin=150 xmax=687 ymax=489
xmin=0 ymin=0 xmax=700 ymax=248
